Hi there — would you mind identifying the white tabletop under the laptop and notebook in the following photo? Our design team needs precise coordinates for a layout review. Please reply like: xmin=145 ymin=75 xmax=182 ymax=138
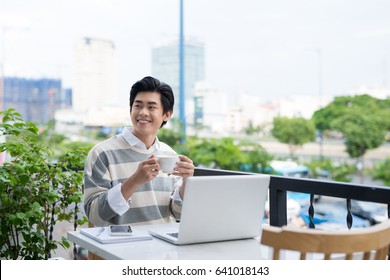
xmin=67 ymin=225 xmax=269 ymax=260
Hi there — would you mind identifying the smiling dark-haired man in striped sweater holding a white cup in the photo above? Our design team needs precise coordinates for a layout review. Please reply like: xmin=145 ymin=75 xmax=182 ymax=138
xmin=84 ymin=77 xmax=194 ymax=226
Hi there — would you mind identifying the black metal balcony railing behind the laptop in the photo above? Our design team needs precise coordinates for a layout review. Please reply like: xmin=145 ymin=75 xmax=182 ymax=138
xmin=195 ymin=168 xmax=390 ymax=228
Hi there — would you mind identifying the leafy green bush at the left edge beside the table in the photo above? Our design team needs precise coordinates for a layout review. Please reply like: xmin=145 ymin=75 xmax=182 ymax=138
xmin=0 ymin=109 xmax=86 ymax=259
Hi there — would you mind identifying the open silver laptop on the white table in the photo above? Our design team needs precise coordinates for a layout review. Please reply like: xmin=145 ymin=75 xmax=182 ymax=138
xmin=149 ymin=174 xmax=270 ymax=245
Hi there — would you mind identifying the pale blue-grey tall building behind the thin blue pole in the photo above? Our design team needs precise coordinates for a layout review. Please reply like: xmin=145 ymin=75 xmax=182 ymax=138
xmin=152 ymin=40 xmax=205 ymax=116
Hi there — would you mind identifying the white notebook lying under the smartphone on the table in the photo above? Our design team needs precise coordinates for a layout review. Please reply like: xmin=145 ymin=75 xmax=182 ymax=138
xmin=80 ymin=227 xmax=152 ymax=244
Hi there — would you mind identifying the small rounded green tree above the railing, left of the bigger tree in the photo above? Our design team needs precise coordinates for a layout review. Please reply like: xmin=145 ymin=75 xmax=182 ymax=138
xmin=271 ymin=117 xmax=315 ymax=157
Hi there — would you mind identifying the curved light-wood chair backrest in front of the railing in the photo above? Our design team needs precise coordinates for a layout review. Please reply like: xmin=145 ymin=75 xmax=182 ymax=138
xmin=260 ymin=219 xmax=390 ymax=260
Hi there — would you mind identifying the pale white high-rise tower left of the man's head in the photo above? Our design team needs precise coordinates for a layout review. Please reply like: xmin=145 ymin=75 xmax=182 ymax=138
xmin=72 ymin=38 xmax=118 ymax=112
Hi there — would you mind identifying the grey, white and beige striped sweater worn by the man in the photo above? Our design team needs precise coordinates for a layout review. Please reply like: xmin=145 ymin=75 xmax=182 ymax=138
xmin=84 ymin=134 xmax=182 ymax=226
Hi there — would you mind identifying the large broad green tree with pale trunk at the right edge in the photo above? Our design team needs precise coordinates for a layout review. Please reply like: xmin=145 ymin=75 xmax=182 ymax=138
xmin=313 ymin=94 xmax=390 ymax=183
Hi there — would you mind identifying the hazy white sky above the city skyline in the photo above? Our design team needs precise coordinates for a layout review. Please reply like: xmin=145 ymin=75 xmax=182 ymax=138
xmin=0 ymin=0 xmax=390 ymax=104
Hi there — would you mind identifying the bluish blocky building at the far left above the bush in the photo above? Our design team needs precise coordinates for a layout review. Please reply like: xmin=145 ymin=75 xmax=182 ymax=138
xmin=4 ymin=77 xmax=64 ymax=123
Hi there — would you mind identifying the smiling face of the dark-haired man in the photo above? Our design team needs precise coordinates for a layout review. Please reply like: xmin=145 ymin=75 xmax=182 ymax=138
xmin=130 ymin=91 xmax=172 ymax=140
